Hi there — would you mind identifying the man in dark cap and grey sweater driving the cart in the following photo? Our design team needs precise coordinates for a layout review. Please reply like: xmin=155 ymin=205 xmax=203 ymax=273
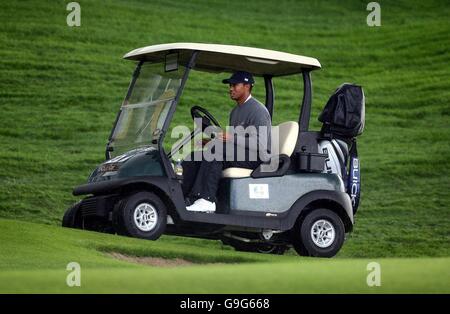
xmin=182 ymin=71 xmax=272 ymax=212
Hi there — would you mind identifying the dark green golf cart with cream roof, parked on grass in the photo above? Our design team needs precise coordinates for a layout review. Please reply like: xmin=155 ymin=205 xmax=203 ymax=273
xmin=62 ymin=43 xmax=362 ymax=257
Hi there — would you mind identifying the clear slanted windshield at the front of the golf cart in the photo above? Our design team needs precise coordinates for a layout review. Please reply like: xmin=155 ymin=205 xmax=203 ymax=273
xmin=108 ymin=62 xmax=185 ymax=157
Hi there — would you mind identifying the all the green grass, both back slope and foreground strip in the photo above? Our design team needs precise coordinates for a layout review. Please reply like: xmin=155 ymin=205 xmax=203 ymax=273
xmin=0 ymin=0 xmax=450 ymax=293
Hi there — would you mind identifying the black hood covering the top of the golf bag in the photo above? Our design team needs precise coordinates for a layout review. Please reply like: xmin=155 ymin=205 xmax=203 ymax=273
xmin=319 ymin=83 xmax=365 ymax=140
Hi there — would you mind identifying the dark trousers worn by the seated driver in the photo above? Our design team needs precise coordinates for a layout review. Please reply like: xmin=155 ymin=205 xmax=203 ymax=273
xmin=182 ymin=143 xmax=261 ymax=202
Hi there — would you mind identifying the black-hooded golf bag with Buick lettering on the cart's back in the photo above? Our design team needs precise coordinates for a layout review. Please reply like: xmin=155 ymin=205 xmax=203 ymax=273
xmin=319 ymin=83 xmax=365 ymax=213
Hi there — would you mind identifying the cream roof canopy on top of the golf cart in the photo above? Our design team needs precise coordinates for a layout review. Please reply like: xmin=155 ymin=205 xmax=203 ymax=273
xmin=124 ymin=43 xmax=320 ymax=76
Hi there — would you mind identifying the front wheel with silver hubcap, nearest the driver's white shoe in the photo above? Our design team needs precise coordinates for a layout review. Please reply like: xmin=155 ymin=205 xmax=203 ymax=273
xmin=113 ymin=191 xmax=167 ymax=240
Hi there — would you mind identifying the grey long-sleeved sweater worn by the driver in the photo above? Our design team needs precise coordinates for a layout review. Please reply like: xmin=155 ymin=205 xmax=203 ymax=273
xmin=230 ymin=97 xmax=272 ymax=161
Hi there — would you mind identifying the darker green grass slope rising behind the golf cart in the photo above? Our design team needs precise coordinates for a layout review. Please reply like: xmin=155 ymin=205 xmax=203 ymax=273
xmin=0 ymin=0 xmax=450 ymax=257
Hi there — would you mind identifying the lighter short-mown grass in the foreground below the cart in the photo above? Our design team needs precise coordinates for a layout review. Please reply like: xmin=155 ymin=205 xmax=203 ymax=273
xmin=0 ymin=219 xmax=450 ymax=294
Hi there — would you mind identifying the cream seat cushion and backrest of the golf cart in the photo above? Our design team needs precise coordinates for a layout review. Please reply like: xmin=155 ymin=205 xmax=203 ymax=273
xmin=222 ymin=121 xmax=299 ymax=178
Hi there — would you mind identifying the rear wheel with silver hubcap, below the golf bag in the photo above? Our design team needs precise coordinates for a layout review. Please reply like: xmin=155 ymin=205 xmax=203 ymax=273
xmin=292 ymin=208 xmax=345 ymax=257
